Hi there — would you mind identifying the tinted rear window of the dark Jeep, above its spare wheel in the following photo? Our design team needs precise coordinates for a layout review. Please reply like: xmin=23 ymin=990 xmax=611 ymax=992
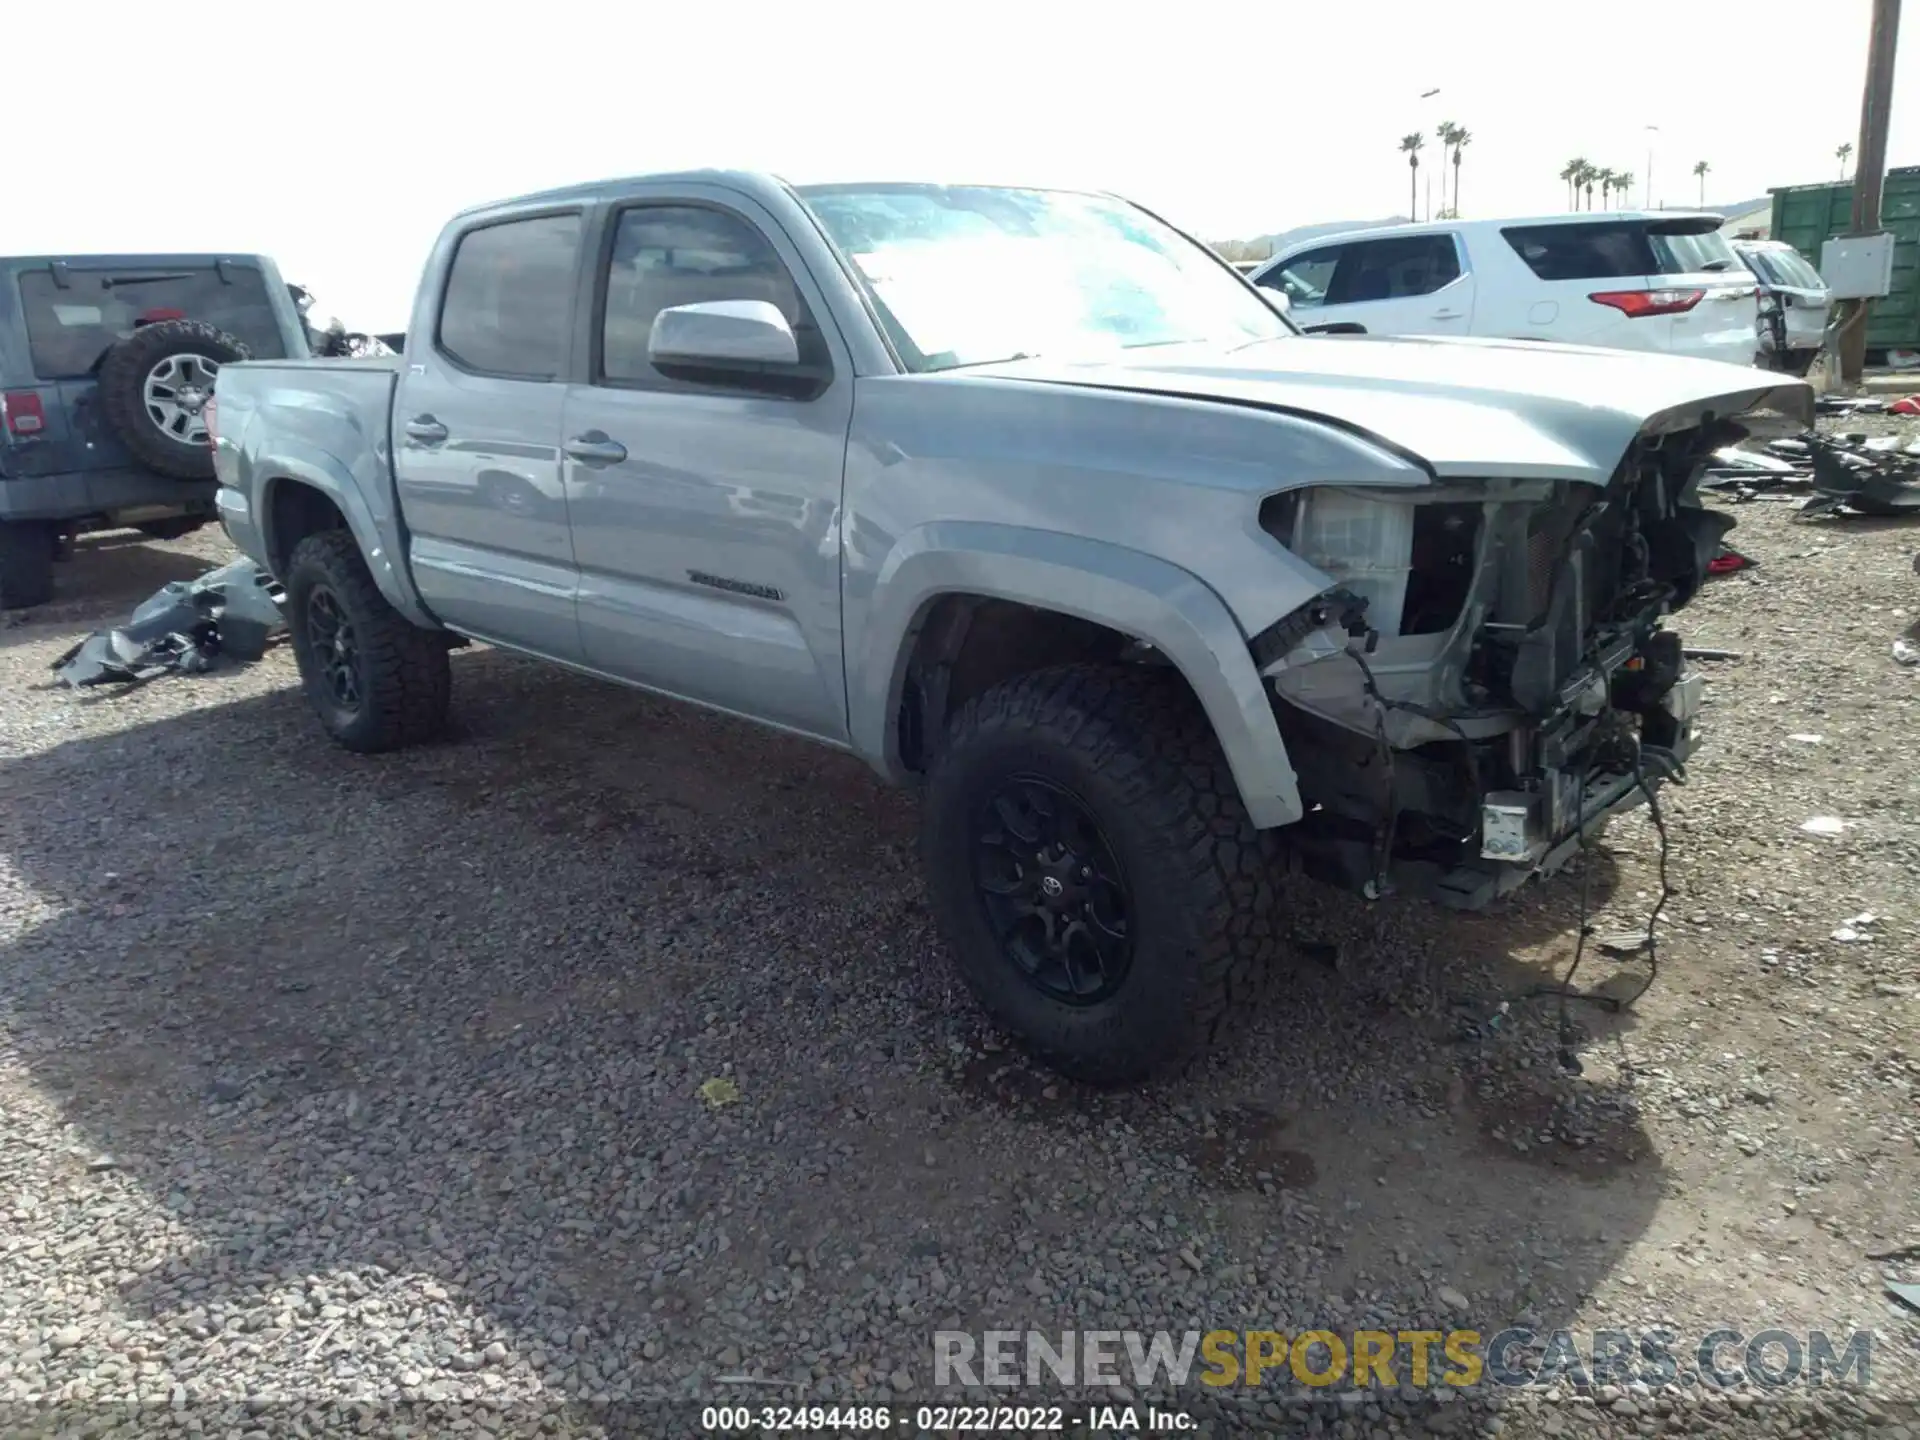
xmin=19 ymin=261 xmax=292 ymax=380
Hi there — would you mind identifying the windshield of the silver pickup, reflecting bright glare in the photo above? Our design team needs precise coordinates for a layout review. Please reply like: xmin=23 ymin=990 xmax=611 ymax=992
xmin=799 ymin=184 xmax=1298 ymax=371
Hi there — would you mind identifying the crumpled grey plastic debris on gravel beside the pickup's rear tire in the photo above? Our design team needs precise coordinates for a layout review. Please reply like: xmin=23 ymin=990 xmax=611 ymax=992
xmin=54 ymin=561 xmax=286 ymax=689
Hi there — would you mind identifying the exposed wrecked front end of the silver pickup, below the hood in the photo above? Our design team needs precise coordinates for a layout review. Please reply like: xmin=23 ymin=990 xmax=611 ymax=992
xmin=1252 ymin=422 xmax=1741 ymax=908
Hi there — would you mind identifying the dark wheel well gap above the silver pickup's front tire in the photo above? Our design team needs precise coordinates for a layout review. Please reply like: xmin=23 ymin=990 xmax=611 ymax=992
xmin=895 ymin=595 xmax=1185 ymax=772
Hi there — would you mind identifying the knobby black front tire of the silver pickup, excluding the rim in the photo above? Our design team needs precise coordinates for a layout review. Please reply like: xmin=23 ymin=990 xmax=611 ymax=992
xmin=922 ymin=664 xmax=1279 ymax=1083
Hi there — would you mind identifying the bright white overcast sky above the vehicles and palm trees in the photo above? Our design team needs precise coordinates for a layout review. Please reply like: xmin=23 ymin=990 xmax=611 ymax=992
xmin=0 ymin=0 xmax=1920 ymax=330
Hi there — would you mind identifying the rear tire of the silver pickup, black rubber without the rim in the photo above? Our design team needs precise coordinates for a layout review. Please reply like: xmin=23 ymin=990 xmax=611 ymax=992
xmin=286 ymin=530 xmax=453 ymax=755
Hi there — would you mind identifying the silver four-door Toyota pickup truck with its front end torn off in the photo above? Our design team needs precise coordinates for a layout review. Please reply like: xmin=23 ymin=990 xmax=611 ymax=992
xmin=211 ymin=173 xmax=1812 ymax=1081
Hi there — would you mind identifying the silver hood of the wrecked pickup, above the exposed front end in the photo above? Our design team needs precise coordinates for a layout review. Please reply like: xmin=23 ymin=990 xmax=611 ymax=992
xmin=975 ymin=336 xmax=1814 ymax=484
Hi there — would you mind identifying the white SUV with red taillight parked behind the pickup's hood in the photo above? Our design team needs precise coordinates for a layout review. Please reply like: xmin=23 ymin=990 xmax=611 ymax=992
xmin=1248 ymin=211 xmax=1761 ymax=374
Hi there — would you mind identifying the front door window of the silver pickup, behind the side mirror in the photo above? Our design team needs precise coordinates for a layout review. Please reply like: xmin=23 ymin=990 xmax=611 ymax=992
xmin=599 ymin=205 xmax=829 ymax=384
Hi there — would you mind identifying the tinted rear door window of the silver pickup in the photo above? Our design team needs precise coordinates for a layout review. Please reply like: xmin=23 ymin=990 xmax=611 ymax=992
xmin=440 ymin=215 xmax=580 ymax=380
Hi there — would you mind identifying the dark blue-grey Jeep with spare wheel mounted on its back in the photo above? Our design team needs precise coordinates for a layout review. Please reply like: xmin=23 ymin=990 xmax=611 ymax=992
xmin=0 ymin=255 xmax=309 ymax=609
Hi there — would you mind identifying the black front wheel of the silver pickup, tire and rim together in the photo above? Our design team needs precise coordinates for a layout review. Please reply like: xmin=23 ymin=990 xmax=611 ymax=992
xmin=922 ymin=664 xmax=1277 ymax=1083
